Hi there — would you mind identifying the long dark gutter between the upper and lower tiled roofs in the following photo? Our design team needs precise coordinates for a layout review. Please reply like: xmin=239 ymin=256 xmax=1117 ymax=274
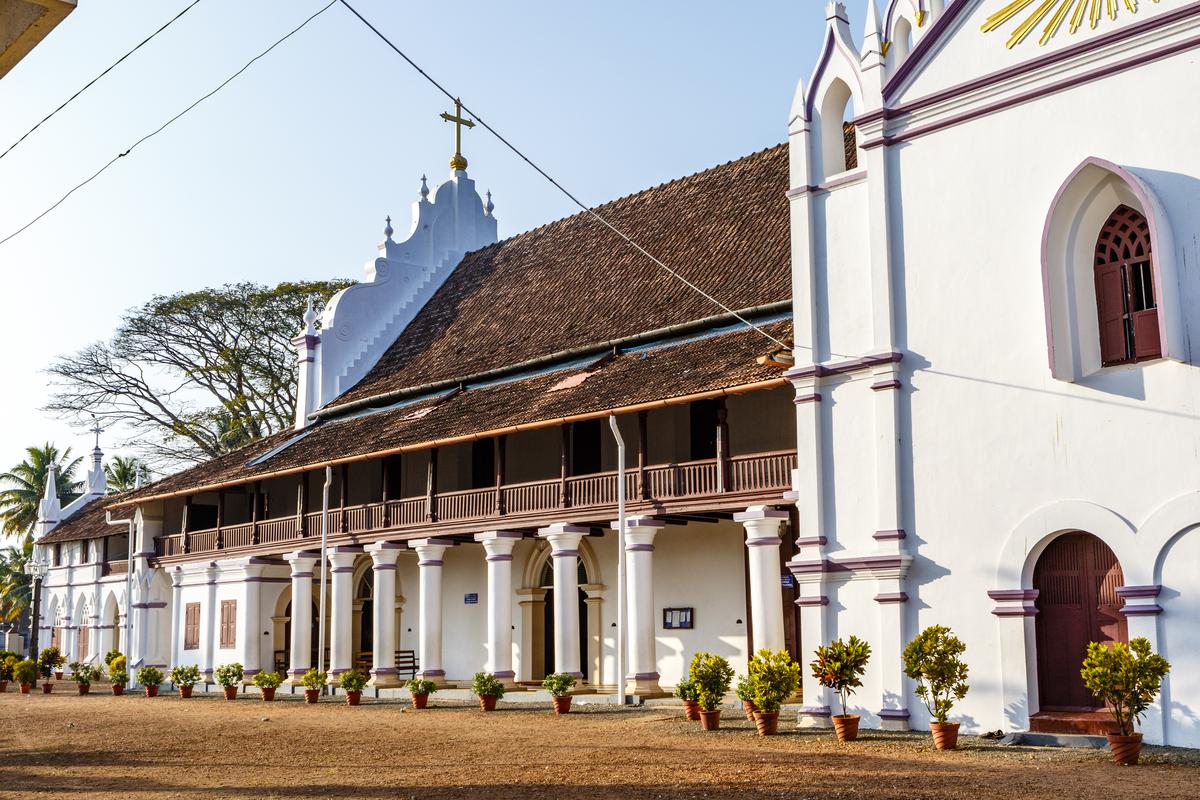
xmin=308 ymin=300 xmax=792 ymax=422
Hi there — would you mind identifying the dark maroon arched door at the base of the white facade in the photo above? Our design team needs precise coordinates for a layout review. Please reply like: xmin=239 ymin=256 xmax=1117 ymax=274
xmin=1033 ymin=533 xmax=1129 ymax=711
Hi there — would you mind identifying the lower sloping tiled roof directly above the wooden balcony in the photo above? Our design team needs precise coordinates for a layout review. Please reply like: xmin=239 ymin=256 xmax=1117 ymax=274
xmin=110 ymin=320 xmax=791 ymax=500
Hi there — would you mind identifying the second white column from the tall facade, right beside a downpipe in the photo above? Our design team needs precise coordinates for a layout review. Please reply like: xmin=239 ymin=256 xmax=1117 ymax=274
xmin=612 ymin=517 xmax=666 ymax=696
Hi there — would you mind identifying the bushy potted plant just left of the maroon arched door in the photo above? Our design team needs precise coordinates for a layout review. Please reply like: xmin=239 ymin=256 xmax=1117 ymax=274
xmin=904 ymin=625 xmax=968 ymax=750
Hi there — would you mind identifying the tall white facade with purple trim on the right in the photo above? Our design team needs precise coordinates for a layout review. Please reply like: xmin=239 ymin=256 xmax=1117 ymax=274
xmin=790 ymin=0 xmax=1200 ymax=746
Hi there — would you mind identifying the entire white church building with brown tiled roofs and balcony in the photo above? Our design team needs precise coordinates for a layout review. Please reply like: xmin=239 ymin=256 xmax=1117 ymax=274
xmin=30 ymin=0 xmax=1200 ymax=747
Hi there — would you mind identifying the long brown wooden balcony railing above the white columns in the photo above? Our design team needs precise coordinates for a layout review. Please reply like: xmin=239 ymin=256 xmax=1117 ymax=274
xmin=155 ymin=450 xmax=796 ymax=558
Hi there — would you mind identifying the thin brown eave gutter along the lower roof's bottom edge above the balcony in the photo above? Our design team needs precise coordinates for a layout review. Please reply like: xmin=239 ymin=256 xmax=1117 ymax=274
xmin=108 ymin=377 xmax=790 ymax=509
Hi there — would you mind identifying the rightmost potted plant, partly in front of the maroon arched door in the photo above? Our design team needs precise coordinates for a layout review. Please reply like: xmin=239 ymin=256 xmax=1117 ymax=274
xmin=1080 ymin=637 xmax=1171 ymax=766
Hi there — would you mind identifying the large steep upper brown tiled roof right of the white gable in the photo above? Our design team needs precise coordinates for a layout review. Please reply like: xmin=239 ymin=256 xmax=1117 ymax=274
xmin=330 ymin=145 xmax=791 ymax=408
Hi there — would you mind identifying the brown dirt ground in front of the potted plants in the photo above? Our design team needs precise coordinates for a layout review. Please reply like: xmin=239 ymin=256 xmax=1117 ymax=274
xmin=0 ymin=685 xmax=1200 ymax=800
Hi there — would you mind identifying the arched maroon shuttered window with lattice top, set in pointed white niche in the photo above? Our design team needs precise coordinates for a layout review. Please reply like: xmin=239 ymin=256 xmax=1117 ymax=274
xmin=1093 ymin=205 xmax=1163 ymax=367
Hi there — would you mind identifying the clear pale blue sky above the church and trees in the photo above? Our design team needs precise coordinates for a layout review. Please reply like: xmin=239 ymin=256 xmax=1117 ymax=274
xmin=0 ymin=0 xmax=865 ymax=494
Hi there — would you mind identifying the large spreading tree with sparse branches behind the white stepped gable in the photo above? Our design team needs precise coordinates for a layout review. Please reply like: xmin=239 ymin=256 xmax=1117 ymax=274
xmin=47 ymin=281 xmax=350 ymax=467
